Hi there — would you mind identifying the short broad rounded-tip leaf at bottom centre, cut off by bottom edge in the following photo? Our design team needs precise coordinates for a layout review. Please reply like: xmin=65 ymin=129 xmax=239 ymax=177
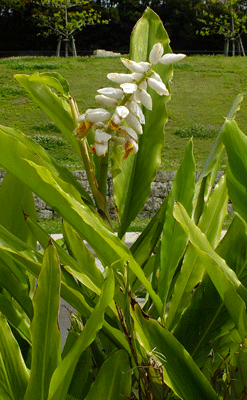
xmin=85 ymin=350 xmax=131 ymax=400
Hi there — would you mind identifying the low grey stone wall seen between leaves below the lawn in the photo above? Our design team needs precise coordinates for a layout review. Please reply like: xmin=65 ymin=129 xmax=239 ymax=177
xmin=0 ymin=171 xmax=226 ymax=219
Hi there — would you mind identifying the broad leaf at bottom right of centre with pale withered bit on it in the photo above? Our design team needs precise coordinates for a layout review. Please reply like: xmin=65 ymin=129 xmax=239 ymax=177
xmin=131 ymin=304 xmax=218 ymax=400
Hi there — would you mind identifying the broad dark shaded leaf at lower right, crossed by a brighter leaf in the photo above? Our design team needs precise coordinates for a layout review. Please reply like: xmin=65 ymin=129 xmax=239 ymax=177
xmin=173 ymin=218 xmax=247 ymax=367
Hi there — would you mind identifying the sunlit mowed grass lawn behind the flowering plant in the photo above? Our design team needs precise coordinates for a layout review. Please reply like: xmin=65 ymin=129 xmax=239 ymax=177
xmin=0 ymin=52 xmax=247 ymax=170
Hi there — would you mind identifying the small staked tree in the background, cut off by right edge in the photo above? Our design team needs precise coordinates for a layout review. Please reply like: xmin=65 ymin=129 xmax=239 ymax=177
xmin=200 ymin=0 xmax=247 ymax=56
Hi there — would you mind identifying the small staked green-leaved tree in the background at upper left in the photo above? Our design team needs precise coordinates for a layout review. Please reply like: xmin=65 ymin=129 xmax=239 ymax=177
xmin=33 ymin=0 xmax=107 ymax=57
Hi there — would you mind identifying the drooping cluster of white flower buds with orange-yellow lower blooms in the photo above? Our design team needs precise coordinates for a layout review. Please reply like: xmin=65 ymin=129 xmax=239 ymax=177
xmin=75 ymin=42 xmax=185 ymax=158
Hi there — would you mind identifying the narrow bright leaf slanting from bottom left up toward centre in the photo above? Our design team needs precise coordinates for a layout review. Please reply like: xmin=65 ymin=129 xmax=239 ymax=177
xmin=48 ymin=270 xmax=114 ymax=400
